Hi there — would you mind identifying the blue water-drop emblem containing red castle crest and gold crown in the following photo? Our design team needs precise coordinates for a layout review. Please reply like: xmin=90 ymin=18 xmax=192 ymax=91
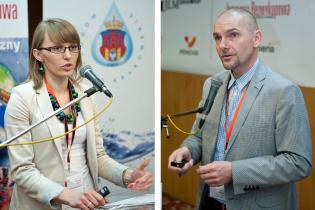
xmin=92 ymin=3 xmax=132 ymax=66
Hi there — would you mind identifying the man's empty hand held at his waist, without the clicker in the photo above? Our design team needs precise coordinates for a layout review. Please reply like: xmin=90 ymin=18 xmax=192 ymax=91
xmin=197 ymin=161 xmax=232 ymax=187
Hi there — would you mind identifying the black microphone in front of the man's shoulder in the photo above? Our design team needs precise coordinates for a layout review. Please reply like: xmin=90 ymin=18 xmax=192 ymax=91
xmin=198 ymin=79 xmax=222 ymax=129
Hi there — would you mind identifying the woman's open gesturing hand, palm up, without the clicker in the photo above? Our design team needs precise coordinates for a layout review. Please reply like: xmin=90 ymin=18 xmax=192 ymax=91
xmin=124 ymin=159 xmax=153 ymax=192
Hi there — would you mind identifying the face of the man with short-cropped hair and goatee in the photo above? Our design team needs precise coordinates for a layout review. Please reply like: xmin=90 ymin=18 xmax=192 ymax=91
xmin=213 ymin=15 xmax=258 ymax=72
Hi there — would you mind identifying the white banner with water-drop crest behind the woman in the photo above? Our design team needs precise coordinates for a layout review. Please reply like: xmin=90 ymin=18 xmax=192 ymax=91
xmin=43 ymin=0 xmax=154 ymax=195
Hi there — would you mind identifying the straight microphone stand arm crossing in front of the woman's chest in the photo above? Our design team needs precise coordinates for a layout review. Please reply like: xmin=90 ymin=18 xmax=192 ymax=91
xmin=0 ymin=87 xmax=97 ymax=149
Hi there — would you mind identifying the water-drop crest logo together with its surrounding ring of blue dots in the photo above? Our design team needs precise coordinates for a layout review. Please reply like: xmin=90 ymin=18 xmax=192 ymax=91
xmin=80 ymin=1 xmax=147 ymax=83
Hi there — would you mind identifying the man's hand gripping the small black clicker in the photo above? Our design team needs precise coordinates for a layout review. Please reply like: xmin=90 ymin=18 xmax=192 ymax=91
xmin=168 ymin=147 xmax=194 ymax=174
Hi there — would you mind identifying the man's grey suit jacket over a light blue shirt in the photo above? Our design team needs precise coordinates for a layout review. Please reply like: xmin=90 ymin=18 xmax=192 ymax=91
xmin=182 ymin=62 xmax=312 ymax=210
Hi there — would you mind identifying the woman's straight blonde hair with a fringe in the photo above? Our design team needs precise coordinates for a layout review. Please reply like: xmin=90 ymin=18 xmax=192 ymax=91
xmin=28 ymin=18 xmax=82 ymax=90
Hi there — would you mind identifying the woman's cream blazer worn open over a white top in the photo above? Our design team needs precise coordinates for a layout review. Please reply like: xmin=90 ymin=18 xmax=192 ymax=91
xmin=5 ymin=82 xmax=126 ymax=210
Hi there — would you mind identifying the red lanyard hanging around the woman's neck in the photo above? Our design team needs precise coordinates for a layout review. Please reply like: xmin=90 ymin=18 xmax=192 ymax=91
xmin=45 ymin=79 xmax=77 ymax=170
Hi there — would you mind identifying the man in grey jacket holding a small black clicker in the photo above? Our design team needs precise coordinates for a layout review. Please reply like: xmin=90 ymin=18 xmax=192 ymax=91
xmin=169 ymin=8 xmax=312 ymax=210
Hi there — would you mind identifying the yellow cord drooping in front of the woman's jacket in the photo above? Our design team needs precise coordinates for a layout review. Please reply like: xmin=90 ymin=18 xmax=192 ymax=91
xmin=0 ymin=97 xmax=113 ymax=148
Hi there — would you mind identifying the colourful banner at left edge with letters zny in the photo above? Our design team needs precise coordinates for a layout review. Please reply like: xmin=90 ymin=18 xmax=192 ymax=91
xmin=0 ymin=0 xmax=28 ymax=210
